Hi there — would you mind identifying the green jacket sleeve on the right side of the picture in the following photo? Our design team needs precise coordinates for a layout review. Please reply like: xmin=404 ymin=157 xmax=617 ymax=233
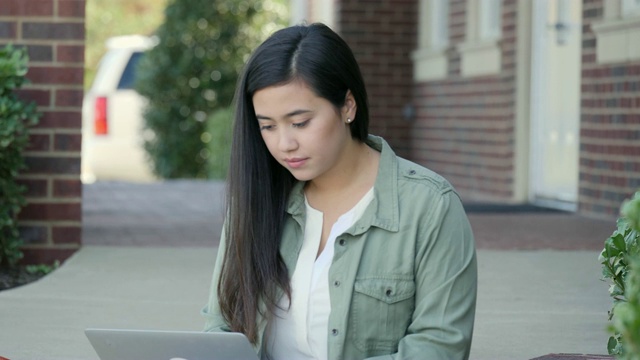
xmin=371 ymin=190 xmax=477 ymax=360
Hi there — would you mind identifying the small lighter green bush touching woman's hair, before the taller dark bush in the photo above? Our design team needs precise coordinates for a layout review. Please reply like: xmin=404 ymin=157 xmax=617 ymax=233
xmin=202 ymin=107 xmax=233 ymax=179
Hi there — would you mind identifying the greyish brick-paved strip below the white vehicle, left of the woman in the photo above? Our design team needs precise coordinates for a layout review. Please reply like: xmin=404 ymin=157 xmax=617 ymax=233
xmin=82 ymin=181 xmax=224 ymax=247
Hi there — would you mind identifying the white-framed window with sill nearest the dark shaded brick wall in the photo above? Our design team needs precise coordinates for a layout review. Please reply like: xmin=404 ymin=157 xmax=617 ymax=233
xmin=411 ymin=0 xmax=449 ymax=82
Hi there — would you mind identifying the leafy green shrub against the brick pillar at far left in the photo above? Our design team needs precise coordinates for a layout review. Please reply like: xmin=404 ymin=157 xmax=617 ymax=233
xmin=0 ymin=45 xmax=39 ymax=266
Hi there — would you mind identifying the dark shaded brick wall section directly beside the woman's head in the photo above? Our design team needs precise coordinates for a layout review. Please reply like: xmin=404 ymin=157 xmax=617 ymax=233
xmin=336 ymin=0 xmax=418 ymax=157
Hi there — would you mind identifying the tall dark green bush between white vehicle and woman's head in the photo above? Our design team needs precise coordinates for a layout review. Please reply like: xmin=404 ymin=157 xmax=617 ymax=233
xmin=136 ymin=0 xmax=286 ymax=178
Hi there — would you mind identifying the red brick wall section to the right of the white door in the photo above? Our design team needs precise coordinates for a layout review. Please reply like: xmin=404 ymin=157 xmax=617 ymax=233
xmin=579 ymin=0 xmax=640 ymax=217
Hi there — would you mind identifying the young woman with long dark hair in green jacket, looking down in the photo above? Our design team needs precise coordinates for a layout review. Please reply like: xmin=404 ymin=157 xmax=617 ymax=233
xmin=203 ymin=24 xmax=477 ymax=360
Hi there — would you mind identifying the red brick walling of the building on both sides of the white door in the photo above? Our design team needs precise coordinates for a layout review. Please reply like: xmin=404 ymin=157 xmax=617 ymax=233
xmin=330 ymin=0 xmax=640 ymax=218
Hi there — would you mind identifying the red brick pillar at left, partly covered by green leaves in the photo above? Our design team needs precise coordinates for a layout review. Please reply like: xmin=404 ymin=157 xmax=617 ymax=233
xmin=0 ymin=0 xmax=85 ymax=263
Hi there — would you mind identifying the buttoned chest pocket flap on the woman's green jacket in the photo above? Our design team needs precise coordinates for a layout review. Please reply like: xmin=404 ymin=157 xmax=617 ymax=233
xmin=355 ymin=279 xmax=416 ymax=304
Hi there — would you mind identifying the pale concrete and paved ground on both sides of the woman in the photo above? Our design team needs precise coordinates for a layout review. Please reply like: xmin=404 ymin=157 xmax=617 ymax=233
xmin=0 ymin=181 xmax=615 ymax=360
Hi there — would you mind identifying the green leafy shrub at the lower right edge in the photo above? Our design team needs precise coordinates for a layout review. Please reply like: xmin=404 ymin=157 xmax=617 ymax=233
xmin=598 ymin=191 xmax=640 ymax=360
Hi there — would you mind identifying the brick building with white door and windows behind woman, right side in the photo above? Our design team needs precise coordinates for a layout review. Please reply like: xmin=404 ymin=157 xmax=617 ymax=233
xmin=292 ymin=0 xmax=640 ymax=219
